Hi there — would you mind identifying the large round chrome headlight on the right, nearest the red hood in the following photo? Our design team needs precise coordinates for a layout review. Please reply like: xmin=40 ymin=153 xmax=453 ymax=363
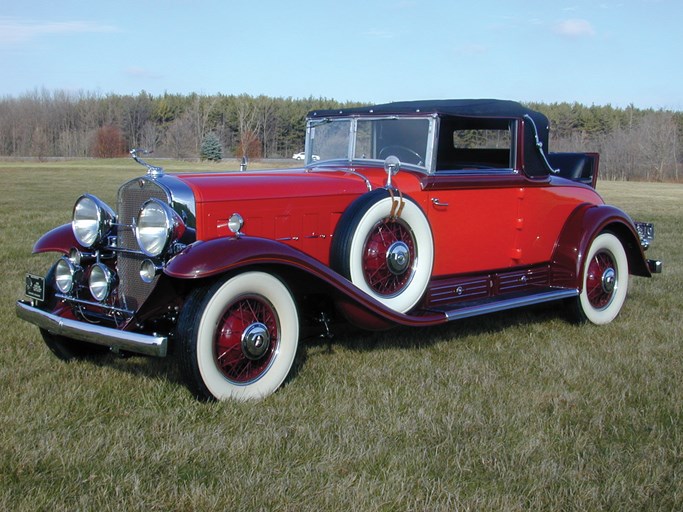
xmin=135 ymin=199 xmax=185 ymax=257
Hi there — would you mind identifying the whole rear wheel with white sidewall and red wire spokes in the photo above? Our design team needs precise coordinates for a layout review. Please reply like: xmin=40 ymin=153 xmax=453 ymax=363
xmin=575 ymin=233 xmax=628 ymax=325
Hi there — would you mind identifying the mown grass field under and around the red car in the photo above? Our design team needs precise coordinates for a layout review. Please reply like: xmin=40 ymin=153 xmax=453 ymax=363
xmin=0 ymin=160 xmax=683 ymax=511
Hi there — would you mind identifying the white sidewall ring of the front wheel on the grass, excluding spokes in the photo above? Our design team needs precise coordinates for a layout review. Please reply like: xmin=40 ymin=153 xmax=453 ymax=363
xmin=194 ymin=272 xmax=299 ymax=400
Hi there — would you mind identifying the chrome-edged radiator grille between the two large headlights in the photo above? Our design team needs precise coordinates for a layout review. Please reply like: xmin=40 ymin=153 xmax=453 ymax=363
xmin=116 ymin=178 xmax=169 ymax=311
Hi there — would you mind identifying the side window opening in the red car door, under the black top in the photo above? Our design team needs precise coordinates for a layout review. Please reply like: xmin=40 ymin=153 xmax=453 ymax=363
xmin=437 ymin=118 xmax=517 ymax=171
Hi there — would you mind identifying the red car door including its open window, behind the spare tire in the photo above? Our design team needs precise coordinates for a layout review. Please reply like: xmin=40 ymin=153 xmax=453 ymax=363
xmin=423 ymin=117 xmax=523 ymax=275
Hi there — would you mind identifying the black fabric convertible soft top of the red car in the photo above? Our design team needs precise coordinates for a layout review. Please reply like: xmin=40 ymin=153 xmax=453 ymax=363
xmin=308 ymin=99 xmax=550 ymax=176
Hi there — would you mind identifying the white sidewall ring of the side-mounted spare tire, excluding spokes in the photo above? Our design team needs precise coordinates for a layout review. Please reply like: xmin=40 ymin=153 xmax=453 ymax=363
xmin=348 ymin=192 xmax=434 ymax=313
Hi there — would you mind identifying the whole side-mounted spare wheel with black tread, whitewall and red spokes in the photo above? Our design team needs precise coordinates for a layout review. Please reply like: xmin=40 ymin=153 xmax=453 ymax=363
xmin=330 ymin=188 xmax=434 ymax=313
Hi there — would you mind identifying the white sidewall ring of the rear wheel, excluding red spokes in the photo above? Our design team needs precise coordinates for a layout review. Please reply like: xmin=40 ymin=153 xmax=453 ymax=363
xmin=578 ymin=233 xmax=628 ymax=325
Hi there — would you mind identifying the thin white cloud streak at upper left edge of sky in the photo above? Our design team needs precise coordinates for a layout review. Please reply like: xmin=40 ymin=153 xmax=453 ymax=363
xmin=0 ymin=17 xmax=119 ymax=45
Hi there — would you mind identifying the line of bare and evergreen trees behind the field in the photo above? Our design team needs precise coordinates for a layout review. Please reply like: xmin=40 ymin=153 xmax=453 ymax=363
xmin=0 ymin=90 xmax=683 ymax=181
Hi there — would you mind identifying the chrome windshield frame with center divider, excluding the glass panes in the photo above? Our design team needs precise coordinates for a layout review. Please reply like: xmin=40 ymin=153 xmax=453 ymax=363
xmin=305 ymin=114 xmax=439 ymax=174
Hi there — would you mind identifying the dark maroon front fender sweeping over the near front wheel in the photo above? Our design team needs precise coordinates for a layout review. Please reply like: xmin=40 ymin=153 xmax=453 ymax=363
xmin=164 ymin=236 xmax=447 ymax=330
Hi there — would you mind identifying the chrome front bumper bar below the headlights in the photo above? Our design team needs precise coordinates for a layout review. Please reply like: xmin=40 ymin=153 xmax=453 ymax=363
xmin=16 ymin=301 xmax=168 ymax=357
